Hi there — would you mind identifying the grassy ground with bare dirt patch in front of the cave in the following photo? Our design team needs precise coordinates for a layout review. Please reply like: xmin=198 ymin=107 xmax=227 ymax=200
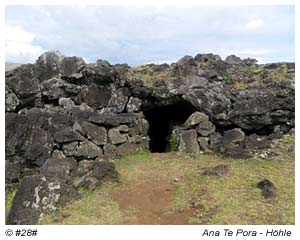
xmin=40 ymin=137 xmax=295 ymax=224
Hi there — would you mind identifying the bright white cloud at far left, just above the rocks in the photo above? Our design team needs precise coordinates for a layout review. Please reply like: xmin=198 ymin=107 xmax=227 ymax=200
xmin=5 ymin=25 xmax=45 ymax=63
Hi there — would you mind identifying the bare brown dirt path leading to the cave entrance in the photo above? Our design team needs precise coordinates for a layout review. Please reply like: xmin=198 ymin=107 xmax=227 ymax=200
xmin=112 ymin=153 xmax=192 ymax=224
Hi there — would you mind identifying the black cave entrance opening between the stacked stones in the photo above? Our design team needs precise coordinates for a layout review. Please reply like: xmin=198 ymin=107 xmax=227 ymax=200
xmin=144 ymin=100 xmax=196 ymax=152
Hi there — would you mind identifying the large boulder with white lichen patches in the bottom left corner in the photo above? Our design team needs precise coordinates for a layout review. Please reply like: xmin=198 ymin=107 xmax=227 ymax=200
xmin=7 ymin=175 xmax=78 ymax=225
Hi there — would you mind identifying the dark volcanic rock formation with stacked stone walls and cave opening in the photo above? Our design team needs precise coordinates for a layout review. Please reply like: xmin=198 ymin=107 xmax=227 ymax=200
xmin=5 ymin=52 xmax=295 ymax=224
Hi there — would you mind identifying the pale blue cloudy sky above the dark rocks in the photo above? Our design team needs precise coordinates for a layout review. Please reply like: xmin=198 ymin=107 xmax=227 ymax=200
xmin=5 ymin=5 xmax=295 ymax=66
